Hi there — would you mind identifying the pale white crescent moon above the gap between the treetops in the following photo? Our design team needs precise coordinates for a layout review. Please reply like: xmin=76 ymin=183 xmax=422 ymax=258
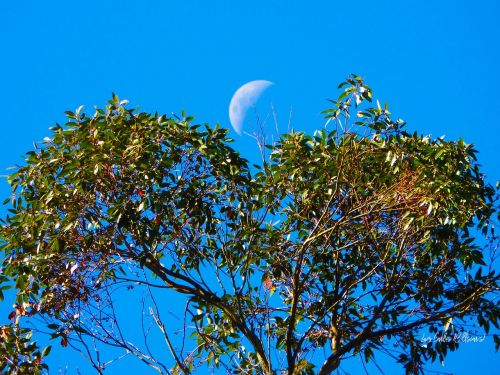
xmin=229 ymin=79 xmax=274 ymax=135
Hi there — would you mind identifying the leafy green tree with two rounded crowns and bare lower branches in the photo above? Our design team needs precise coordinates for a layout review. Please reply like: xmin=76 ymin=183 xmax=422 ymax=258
xmin=0 ymin=76 xmax=500 ymax=375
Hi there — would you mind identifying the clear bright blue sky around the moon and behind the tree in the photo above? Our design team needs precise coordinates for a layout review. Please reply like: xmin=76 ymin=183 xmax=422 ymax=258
xmin=0 ymin=0 xmax=500 ymax=374
